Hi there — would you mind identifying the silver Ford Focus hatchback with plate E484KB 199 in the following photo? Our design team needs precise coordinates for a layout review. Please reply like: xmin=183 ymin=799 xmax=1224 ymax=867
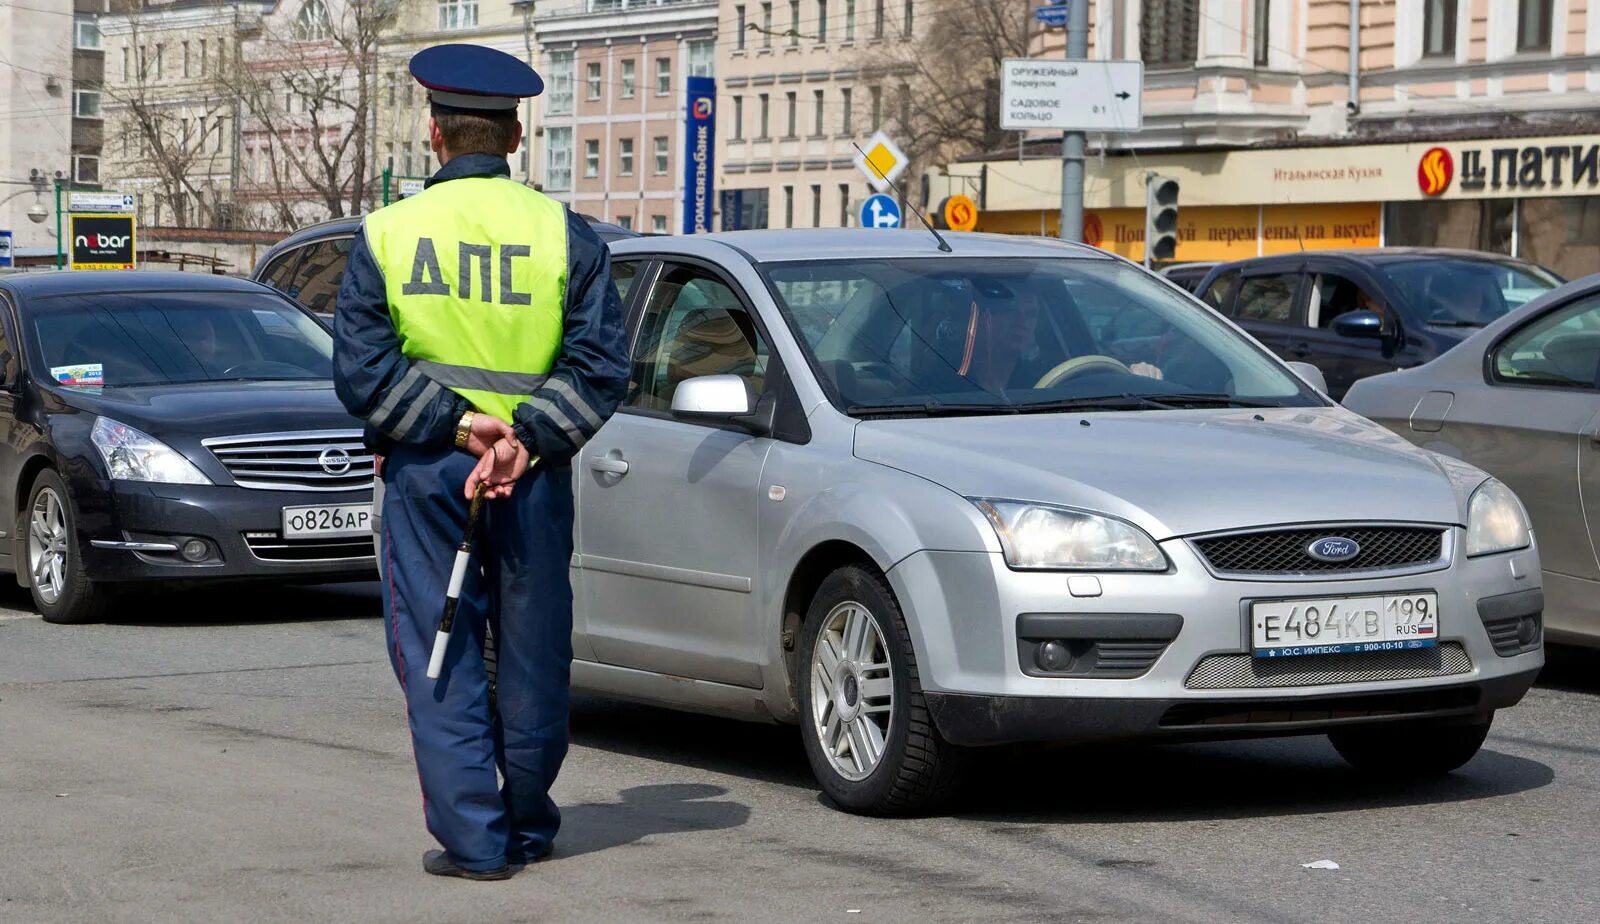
xmin=573 ymin=230 xmax=1544 ymax=814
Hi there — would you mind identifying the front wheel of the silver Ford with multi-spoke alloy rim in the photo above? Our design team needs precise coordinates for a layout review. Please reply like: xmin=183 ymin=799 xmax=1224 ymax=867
xmin=797 ymin=566 xmax=970 ymax=815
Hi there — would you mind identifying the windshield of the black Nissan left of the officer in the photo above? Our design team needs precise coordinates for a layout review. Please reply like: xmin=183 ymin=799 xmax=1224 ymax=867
xmin=26 ymin=293 xmax=333 ymax=387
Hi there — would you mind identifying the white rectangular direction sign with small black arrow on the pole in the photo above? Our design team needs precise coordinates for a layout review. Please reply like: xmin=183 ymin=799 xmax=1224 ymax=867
xmin=1000 ymin=58 xmax=1144 ymax=131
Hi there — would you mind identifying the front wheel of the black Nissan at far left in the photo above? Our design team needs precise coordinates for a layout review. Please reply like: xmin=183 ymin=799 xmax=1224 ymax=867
xmin=18 ymin=468 xmax=110 ymax=625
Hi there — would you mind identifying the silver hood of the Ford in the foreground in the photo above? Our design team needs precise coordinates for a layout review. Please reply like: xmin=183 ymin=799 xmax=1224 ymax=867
xmin=856 ymin=408 xmax=1470 ymax=540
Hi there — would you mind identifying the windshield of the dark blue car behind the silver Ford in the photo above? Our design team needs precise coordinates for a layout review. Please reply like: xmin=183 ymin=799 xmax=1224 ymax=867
xmin=1387 ymin=257 xmax=1562 ymax=328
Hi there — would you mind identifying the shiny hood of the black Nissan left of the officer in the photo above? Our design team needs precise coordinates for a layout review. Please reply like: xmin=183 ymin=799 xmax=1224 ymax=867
xmin=56 ymin=379 xmax=362 ymax=440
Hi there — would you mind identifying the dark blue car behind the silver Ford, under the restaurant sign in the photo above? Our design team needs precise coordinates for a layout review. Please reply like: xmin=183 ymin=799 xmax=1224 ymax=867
xmin=1197 ymin=248 xmax=1562 ymax=398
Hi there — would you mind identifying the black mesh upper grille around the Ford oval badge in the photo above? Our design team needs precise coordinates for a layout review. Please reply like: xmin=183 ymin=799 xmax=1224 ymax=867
xmin=1194 ymin=524 xmax=1445 ymax=576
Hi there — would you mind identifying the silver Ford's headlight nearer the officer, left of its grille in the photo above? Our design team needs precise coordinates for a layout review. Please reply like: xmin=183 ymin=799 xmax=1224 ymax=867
xmin=970 ymin=497 xmax=1166 ymax=571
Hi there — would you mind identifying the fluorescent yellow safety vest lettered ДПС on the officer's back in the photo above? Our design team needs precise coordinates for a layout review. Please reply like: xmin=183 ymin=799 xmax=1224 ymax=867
xmin=363 ymin=176 xmax=570 ymax=422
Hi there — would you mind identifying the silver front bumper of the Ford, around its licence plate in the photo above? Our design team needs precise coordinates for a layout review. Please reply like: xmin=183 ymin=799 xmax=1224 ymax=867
xmin=890 ymin=531 xmax=1544 ymax=743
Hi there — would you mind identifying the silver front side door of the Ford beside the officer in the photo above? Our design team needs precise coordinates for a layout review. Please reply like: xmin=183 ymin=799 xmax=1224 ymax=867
xmin=573 ymin=262 xmax=774 ymax=687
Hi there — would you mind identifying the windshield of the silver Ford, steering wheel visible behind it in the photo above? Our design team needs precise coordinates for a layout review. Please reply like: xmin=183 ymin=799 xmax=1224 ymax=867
xmin=762 ymin=257 xmax=1322 ymax=414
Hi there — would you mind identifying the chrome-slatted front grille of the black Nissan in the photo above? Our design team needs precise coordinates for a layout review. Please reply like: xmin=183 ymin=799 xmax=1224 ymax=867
xmin=202 ymin=430 xmax=373 ymax=491
